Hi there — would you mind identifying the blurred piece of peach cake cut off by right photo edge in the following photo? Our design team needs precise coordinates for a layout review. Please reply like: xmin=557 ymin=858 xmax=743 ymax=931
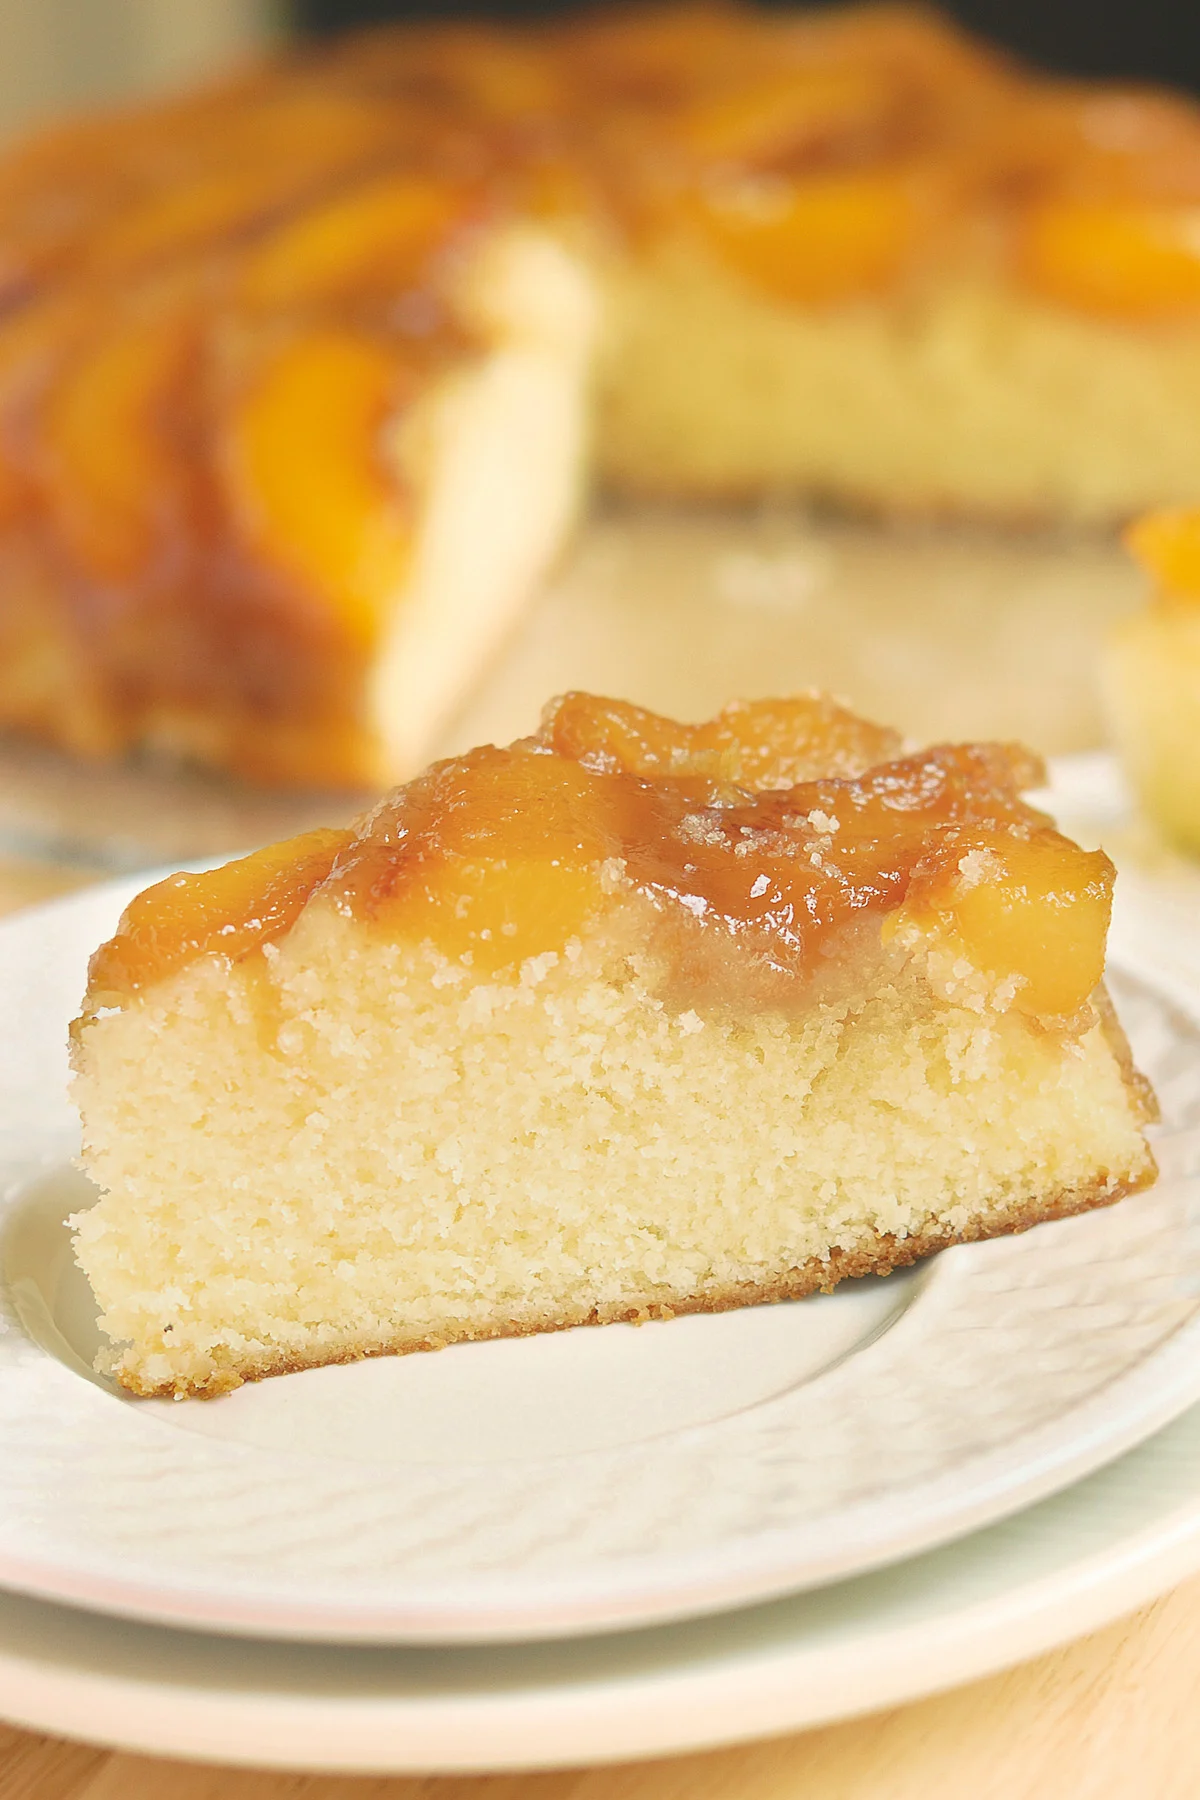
xmin=1105 ymin=508 xmax=1200 ymax=855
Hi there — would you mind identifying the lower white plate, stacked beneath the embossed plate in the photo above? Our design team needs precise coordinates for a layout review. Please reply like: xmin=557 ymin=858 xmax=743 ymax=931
xmin=0 ymin=1389 xmax=1200 ymax=1773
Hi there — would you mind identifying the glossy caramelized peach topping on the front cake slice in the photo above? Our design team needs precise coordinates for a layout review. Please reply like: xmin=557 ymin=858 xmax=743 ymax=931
xmin=92 ymin=695 xmax=1112 ymax=1022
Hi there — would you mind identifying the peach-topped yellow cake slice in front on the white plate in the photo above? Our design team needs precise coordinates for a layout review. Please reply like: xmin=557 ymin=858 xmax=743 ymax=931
xmin=74 ymin=695 xmax=1153 ymax=1397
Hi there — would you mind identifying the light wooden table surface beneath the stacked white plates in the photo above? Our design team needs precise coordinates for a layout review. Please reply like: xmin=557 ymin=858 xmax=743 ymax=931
xmin=0 ymin=859 xmax=1200 ymax=1800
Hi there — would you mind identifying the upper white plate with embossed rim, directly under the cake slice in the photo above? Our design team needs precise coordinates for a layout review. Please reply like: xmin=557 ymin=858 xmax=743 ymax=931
xmin=0 ymin=759 xmax=1200 ymax=1642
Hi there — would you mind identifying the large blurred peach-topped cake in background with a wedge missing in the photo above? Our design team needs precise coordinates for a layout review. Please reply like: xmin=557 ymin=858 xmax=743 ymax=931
xmin=0 ymin=4 xmax=1200 ymax=788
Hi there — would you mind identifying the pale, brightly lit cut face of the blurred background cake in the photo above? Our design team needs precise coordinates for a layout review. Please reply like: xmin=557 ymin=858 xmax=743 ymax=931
xmin=367 ymin=225 xmax=599 ymax=787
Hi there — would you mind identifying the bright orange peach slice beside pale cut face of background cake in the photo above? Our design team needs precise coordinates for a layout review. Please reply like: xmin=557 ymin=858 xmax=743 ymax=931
xmin=218 ymin=329 xmax=412 ymax=641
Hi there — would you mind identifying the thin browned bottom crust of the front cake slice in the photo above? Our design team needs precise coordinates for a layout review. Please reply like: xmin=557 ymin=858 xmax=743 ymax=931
xmin=119 ymin=1159 xmax=1157 ymax=1400
